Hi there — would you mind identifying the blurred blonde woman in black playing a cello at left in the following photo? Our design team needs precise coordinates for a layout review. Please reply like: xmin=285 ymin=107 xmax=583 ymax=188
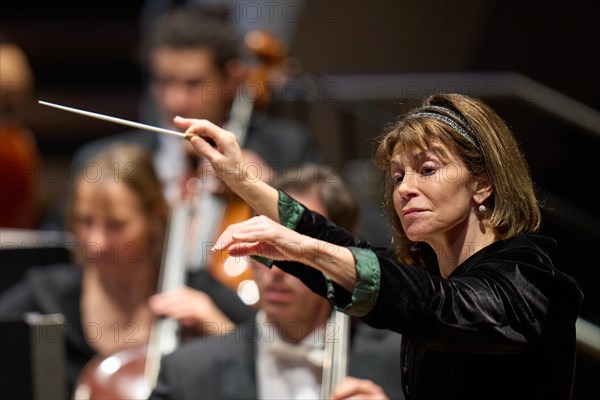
xmin=0 ymin=142 xmax=254 ymax=393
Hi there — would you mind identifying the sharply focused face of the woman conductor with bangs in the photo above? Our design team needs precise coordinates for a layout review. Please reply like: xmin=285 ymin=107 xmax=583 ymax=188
xmin=390 ymin=145 xmax=475 ymax=249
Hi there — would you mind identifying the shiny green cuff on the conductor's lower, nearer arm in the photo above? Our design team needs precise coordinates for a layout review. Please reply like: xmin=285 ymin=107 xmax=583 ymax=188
xmin=325 ymin=247 xmax=381 ymax=317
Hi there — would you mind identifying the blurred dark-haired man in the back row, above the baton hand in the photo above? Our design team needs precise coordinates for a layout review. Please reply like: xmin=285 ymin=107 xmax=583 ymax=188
xmin=73 ymin=4 xmax=317 ymax=206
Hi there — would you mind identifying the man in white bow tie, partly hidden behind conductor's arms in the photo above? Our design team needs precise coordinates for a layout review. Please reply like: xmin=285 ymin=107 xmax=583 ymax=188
xmin=150 ymin=165 xmax=403 ymax=400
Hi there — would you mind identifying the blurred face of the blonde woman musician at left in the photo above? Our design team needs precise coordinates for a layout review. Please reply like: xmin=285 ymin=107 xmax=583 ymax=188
xmin=73 ymin=181 xmax=156 ymax=271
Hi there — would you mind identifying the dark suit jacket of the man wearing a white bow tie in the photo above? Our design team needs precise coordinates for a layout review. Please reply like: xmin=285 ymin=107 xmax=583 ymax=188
xmin=150 ymin=321 xmax=404 ymax=400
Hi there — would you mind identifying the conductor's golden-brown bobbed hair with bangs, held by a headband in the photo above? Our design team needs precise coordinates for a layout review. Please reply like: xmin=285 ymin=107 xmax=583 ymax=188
xmin=374 ymin=93 xmax=541 ymax=265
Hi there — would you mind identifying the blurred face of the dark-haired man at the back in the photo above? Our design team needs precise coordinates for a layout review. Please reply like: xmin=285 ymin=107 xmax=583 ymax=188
xmin=150 ymin=47 xmax=235 ymax=125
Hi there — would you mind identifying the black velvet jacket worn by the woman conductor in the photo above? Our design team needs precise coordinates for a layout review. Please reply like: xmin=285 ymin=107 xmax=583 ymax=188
xmin=277 ymin=211 xmax=583 ymax=400
